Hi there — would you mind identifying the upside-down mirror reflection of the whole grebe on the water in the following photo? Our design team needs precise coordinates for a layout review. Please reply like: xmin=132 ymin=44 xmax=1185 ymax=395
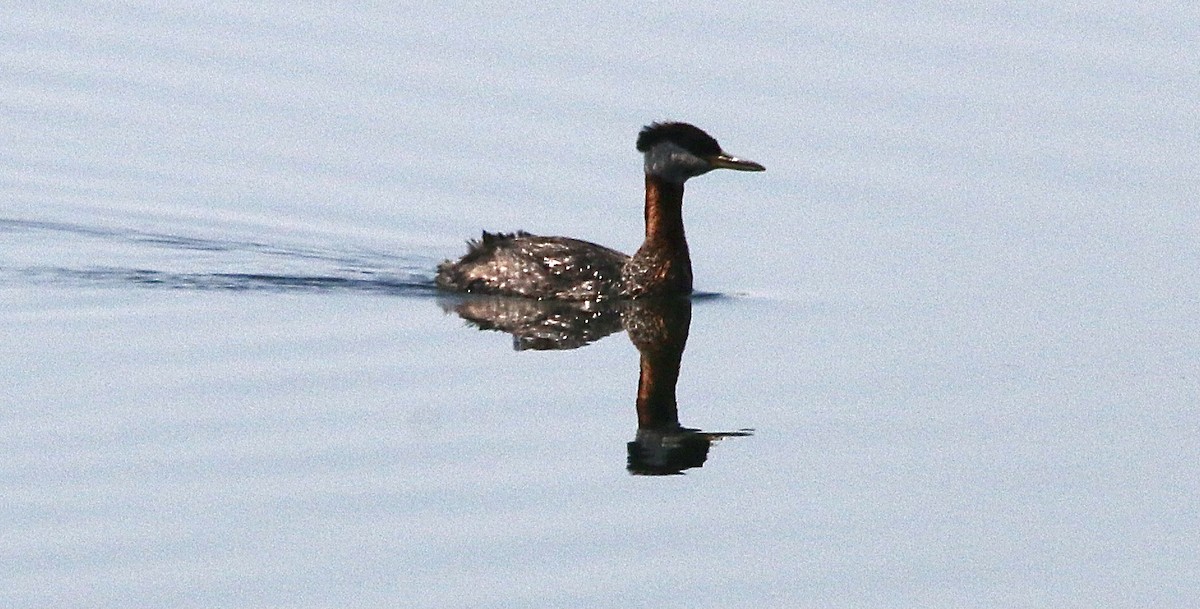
xmin=444 ymin=297 xmax=750 ymax=475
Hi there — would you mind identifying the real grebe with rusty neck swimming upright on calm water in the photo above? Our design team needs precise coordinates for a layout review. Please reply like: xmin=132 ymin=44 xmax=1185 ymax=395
xmin=437 ymin=122 xmax=766 ymax=301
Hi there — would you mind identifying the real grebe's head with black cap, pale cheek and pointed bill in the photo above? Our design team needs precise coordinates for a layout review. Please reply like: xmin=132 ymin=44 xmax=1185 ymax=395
xmin=637 ymin=122 xmax=766 ymax=183
